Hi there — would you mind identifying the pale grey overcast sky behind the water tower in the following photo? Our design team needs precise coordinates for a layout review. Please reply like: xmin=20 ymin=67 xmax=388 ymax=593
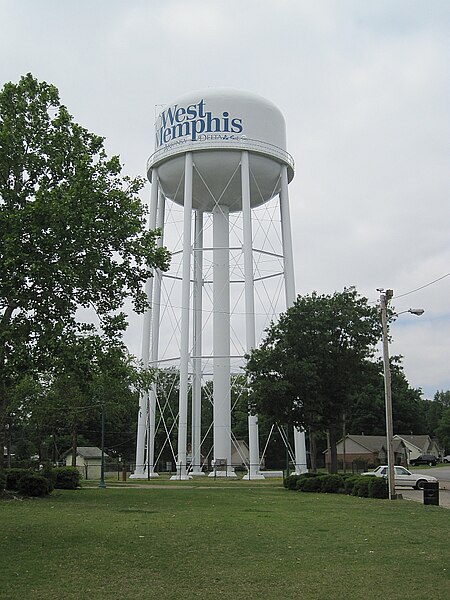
xmin=0 ymin=0 xmax=450 ymax=397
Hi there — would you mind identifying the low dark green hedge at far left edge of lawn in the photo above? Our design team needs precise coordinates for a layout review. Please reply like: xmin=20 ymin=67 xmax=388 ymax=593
xmin=0 ymin=467 xmax=81 ymax=496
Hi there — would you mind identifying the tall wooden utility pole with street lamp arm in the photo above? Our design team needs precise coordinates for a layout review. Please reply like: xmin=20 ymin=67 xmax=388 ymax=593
xmin=378 ymin=290 xmax=425 ymax=500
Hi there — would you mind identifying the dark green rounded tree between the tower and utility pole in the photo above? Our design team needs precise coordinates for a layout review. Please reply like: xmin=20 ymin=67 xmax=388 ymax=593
xmin=246 ymin=288 xmax=381 ymax=471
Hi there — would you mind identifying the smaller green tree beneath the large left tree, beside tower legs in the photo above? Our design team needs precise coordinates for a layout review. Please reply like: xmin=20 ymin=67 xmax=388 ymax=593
xmin=24 ymin=332 xmax=151 ymax=464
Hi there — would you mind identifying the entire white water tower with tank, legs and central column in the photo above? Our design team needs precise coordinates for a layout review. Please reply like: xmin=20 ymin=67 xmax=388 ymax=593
xmin=133 ymin=89 xmax=306 ymax=479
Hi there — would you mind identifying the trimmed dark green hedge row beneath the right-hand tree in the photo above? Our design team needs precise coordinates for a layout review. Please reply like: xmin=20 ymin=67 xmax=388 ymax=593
xmin=283 ymin=473 xmax=389 ymax=499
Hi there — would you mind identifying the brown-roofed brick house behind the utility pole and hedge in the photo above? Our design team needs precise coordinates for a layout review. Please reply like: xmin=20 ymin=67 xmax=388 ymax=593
xmin=324 ymin=434 xmax=409 ymax=466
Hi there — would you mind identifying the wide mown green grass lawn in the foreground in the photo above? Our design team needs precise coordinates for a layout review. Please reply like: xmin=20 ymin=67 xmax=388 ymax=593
xmin=0 ymin=479 xmax=450 ymax=600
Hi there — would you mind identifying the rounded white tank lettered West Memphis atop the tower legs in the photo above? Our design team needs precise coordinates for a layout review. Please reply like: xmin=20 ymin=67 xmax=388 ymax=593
xmin=147 ymin=89 xmax=294 ymax=212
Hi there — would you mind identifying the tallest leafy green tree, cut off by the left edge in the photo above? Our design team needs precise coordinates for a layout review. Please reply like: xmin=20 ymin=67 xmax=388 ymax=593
xmin=0 ymin=74 xmax=168 ymax=465
